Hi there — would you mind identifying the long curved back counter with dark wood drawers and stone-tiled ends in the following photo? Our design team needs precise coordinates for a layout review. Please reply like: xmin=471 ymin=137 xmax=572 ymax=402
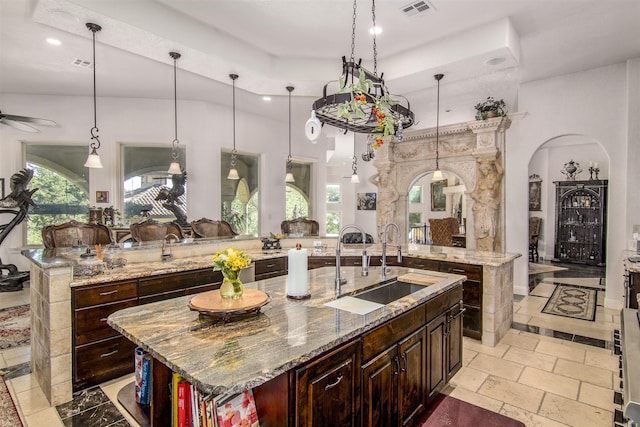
xmin=23 ymin=238 xmax=520 ymax=405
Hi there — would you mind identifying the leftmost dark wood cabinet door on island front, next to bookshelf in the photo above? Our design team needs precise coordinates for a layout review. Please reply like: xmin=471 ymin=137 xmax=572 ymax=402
xmin=294 ymin=340 xmax=361 ymax=427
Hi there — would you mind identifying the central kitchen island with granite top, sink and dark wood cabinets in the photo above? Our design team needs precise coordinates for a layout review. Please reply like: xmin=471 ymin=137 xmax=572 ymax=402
xmin=108 ymin=267 xmax=465 ymax=425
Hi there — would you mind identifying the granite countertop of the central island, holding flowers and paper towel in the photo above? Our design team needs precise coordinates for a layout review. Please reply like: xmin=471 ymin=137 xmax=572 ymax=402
xmin=107 ymin=267 xmax=464 ymax=395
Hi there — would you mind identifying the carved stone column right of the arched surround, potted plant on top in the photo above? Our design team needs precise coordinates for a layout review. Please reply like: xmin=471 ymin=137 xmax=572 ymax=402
xmin=467 ymin=117 xmax=511 ymax=252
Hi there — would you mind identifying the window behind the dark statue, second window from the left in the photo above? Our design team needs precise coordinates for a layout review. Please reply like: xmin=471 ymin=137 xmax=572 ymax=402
xmin=122 ymin=145 xmax=187 ymax=224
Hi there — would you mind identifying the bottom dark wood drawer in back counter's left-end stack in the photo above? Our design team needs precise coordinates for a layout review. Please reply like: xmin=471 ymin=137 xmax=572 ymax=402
xmin=74 ymin=336 xmax=135 ymax=390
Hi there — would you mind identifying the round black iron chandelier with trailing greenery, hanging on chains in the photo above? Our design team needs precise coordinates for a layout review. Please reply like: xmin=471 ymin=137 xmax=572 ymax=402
xmin=312 ymin=0 xmax=414 ymax=144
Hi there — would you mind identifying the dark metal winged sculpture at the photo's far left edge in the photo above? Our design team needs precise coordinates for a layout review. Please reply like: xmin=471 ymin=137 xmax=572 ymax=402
xmin=0 ymin=169 xmax=38 ymax=292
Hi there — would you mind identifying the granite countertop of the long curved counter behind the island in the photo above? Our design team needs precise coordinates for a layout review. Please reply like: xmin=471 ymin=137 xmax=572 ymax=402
xmin=22 ymin=238 xmax=521 ymax=286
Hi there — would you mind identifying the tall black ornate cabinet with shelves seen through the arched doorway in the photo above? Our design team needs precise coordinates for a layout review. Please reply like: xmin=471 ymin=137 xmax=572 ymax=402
xmin=553 ymin=180 xmax=608 ymax=266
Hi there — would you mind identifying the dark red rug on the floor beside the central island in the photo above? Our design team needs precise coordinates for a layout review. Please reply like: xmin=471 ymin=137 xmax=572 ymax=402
xmin=417 ymin=394 xmax=525 ymax=427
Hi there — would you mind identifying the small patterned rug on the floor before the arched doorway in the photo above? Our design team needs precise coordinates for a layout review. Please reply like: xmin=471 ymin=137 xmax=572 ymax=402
xmin=542 ymin=285 xmax=598 ymax=321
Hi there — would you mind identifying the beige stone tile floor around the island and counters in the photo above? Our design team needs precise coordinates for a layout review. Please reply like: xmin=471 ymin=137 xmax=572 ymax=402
xmin=0 ymin=264 xmax=620 ymax=427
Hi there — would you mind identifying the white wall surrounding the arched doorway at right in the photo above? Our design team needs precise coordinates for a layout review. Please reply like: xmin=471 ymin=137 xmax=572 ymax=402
xmin=505 ymin=63 xmax=637 ymax=307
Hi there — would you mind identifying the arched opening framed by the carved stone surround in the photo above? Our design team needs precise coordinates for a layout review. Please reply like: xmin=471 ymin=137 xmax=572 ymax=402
xmin=407 ymin=171 xmax=467 ymax=244
